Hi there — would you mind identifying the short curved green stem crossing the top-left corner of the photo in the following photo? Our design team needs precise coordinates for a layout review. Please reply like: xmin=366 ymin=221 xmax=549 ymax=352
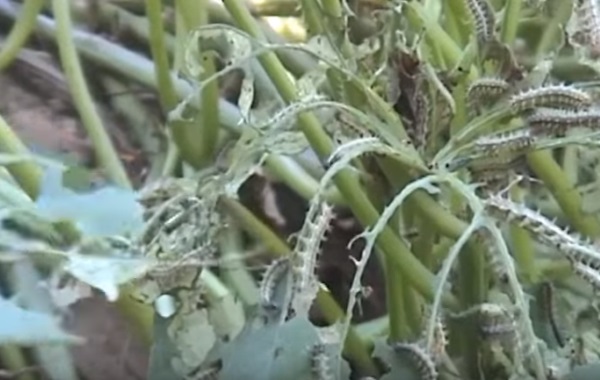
xmin=0 ymin=0 xmax=46 ymax=71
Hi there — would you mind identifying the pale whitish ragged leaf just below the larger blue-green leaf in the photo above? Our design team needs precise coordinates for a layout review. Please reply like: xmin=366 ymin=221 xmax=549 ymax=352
xmin=64 ymin=253 xmax=154 ymax=302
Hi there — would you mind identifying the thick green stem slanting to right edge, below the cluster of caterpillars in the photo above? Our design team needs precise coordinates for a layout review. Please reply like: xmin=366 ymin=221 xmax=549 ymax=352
xmin=527 ymin=150 xmax=600 ymax=237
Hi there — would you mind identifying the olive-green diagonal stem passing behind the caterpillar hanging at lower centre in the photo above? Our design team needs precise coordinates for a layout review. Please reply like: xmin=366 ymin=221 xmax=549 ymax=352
xmin=220 ymin=197 xmax=378 ymax=375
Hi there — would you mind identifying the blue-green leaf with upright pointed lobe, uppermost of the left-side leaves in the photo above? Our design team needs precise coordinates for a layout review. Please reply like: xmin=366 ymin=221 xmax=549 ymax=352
xmin=36 ymin=169 xmax=143 ymax=237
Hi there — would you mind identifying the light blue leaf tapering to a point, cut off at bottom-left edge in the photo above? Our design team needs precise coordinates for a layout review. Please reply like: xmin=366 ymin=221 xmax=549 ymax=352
xmin=0 ymin=298 xmax=82 ymax=346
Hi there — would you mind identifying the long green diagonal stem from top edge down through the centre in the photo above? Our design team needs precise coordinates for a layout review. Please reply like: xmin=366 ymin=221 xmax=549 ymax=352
xmin=223 ymin=0 xmax=458 ymax=307
